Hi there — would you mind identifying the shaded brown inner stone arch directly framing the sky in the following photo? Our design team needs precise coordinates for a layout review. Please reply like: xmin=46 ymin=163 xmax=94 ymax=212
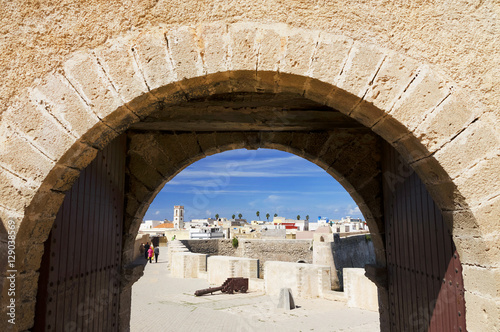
xmin=123 ymin=128 xmax=385 ymax=266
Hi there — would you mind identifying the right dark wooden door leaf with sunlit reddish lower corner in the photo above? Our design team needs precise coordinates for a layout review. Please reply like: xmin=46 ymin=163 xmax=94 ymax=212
xmin=382 ymin=143 xmax=465 ymax=331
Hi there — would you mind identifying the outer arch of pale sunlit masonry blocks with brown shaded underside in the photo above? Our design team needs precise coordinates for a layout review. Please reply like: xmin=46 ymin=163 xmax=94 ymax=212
xmin=0 ymin=22 xmax=500 ymax=329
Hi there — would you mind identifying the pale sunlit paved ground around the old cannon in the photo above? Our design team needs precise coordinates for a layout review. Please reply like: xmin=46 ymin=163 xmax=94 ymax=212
xmin=130 ymin=248 xmax=379 ymax=332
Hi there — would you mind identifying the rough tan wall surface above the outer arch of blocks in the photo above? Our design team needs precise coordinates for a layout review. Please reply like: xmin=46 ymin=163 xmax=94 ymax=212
xmin=0 ymin=0 xmax=500 ymax=113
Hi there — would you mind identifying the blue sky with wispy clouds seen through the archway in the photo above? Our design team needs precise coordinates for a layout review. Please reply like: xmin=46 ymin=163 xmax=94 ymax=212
xmin=144 ymin=149 xmax=362 ymax=221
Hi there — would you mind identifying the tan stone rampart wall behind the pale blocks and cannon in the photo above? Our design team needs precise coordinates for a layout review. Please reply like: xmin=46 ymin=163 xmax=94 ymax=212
xmin=181 ymin=239 xmax=313 ymax=278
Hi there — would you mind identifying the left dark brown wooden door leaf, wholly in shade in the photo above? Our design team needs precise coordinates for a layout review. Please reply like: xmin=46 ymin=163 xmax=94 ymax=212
xmin=35 ymin=137 xmax=126 ymax=331
